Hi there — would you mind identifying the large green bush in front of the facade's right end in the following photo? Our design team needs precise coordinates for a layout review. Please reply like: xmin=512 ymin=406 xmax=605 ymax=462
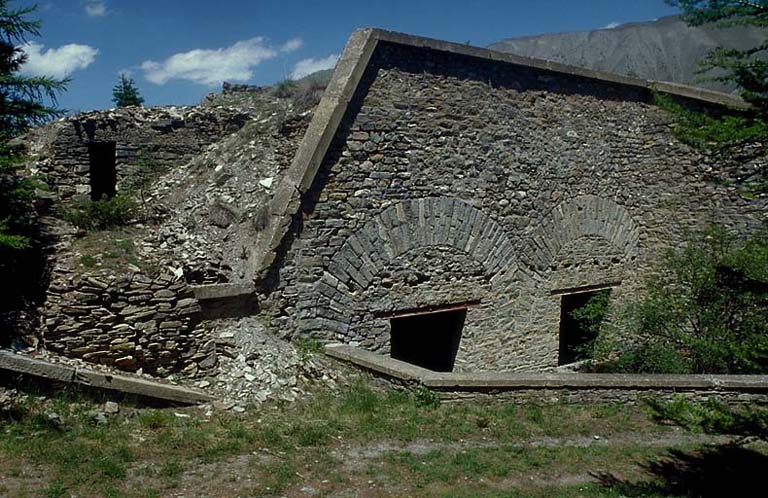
xmin=603 ymin=229 xmax=768 ymax=374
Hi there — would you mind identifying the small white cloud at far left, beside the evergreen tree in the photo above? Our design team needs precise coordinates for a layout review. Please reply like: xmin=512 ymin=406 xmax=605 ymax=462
xmin=20 ymin=42 xmax=99 ymax=78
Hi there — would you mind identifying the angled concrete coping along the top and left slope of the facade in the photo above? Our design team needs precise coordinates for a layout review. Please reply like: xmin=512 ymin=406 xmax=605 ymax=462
xmin=251 ymin=28 xmax=750 ymax=279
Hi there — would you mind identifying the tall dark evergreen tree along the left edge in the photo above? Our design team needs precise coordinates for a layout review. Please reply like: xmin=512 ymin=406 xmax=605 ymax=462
xmin=0 ymin=0 xmax=67 ymax=343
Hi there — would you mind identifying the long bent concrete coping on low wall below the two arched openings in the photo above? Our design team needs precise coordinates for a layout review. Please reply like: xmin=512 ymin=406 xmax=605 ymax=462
xmin=325 ymin=344 xmax=768 ymax=393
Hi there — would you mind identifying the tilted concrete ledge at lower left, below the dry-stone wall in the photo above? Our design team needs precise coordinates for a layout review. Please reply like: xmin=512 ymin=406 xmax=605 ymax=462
xmin=0 ymin=351 xmax=213 ymax=405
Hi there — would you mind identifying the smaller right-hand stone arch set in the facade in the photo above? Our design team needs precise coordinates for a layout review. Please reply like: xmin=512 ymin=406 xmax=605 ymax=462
xmin=524 ymin=195 xmax=640 ymax=272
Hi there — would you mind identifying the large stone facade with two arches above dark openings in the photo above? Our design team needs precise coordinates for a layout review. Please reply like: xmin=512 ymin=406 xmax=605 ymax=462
xmin=265 ymin=43 xmax=766 ymax=370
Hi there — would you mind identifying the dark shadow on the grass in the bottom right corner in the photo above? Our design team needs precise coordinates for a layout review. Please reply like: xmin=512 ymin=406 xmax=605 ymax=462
xmin=595 ymin=445 xmax=768 ymax=497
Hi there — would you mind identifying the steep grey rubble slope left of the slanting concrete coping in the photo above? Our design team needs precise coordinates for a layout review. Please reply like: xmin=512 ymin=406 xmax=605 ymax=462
xmin=139 ymin=97 xmax=311 ymax=284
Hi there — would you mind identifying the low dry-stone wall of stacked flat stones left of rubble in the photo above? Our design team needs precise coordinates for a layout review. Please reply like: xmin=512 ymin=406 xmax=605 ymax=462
xmin=43 ymin=266 xmax=216 ymax=375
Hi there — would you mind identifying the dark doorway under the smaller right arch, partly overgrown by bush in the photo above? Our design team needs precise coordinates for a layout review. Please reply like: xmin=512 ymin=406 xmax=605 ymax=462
xmin=558 ymin=289 xmax=611 ymax=365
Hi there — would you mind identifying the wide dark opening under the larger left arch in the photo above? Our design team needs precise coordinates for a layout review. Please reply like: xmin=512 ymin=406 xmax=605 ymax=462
xmin=391 ymin=308 xmax=467 ymax=372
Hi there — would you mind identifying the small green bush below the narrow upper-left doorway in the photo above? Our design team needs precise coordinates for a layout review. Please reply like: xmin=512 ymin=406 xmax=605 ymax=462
xmin=64 ymin=195 xmax=138 ymax=230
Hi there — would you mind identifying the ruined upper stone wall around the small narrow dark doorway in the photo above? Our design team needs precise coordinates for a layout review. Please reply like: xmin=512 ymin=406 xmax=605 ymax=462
xmin=31 ymin=107 xmax=248 ymax=200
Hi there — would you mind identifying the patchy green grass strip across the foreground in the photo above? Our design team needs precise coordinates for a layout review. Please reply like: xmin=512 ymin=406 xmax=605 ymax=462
xmin=0 ymin=381 xmax=768 ymax=498
